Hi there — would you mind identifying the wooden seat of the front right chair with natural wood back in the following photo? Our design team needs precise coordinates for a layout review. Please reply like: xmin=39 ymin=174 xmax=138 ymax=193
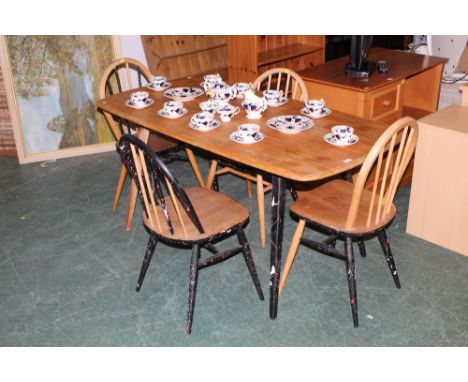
xmin=291 ymin=179 xmax=396 ymax=234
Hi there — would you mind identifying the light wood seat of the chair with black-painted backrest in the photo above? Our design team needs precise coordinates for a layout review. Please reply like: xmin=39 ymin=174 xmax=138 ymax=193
xmin=143 ymin=187 xmax=249 ymax=241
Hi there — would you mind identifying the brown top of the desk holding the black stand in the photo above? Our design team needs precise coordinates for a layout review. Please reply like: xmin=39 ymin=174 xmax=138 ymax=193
xmin=298 ymin=48 xmax=448 ymax=92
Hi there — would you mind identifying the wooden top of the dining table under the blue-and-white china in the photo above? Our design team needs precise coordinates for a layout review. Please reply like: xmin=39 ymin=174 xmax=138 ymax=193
xmin=98 ymin=79 xmax=386 ymax=181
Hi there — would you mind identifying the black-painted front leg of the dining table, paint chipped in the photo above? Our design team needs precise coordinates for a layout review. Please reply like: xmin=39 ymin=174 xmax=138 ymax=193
xmin=270 ymin=176 xmax=286 ymax=319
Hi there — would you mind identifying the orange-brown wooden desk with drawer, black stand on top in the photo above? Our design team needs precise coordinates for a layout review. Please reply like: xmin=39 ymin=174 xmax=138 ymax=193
xmin=299 ymin=48 xmax=447 ymax=123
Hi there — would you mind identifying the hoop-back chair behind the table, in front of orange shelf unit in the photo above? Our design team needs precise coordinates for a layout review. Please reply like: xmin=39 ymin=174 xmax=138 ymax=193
xmin=207 ymin=68 xmax=308 ymax=248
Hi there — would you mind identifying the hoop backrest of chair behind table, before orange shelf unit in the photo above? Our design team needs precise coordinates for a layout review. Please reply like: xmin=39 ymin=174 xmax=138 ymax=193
xmin=253 ymin=68 xmax=309 ymax=102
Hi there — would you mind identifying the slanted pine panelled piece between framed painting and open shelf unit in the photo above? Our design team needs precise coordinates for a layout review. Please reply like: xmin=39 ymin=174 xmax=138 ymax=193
xmin=141 ymin=35 xmax=227 ymax=80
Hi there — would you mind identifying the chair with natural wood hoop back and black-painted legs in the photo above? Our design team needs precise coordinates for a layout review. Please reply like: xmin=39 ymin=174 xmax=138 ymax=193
xmin=279 ymin=117 xmax=418 ymax=327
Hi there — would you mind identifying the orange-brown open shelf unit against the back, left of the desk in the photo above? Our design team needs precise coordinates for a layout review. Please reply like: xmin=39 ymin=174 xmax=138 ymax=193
xmin=227 ymin=35 xmax=325 ymax=83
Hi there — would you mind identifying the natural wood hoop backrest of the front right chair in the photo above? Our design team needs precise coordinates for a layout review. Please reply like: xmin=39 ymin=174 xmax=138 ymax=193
xmin=346 ymin=117 xmax=418 ymax=229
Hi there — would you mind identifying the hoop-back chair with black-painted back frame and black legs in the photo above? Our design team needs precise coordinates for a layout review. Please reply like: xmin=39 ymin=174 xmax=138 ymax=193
xmin=117 ymin=134 xmax=264 ymax=334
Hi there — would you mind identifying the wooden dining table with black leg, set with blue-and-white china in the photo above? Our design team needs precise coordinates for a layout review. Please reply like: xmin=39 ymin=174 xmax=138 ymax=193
xmin=97 ymin=78 xmax=387 ymax=319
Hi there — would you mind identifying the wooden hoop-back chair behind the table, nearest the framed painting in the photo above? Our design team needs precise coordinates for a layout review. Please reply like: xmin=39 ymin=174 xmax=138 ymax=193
xmin=99 ymin=58 xmax=203 ymax=211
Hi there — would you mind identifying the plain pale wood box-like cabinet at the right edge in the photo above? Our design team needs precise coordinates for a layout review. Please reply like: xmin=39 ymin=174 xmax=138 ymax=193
xmin=406 ymin=105 xmax=468 ymax=256
